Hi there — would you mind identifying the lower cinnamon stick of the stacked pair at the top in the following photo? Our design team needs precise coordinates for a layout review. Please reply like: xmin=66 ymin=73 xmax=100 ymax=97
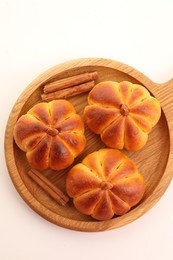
xmin=41 ymin=80 xmax=95 ymax=101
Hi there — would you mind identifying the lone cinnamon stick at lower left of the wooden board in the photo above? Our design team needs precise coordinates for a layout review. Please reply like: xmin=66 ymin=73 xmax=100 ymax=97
xmin=28 ymin=169 xmax=69 ymax=206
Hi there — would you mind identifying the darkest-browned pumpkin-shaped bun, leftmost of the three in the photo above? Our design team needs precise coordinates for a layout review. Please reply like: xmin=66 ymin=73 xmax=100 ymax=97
xmin=14 ymin=99 xmax=86 ymax=170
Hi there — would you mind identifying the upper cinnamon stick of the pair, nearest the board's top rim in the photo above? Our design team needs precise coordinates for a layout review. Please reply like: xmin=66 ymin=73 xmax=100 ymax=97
xmin=43 ymin=71 xmax=98 ymax=93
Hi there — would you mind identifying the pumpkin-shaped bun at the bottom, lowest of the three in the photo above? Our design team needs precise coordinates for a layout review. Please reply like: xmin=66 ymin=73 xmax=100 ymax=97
xmin=66 ymin=148 xmax=145 ymax=220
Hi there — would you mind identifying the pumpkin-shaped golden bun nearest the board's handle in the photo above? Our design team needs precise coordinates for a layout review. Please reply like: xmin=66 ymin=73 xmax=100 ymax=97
xmin=84 ymin=81 xmax=161 ymax=151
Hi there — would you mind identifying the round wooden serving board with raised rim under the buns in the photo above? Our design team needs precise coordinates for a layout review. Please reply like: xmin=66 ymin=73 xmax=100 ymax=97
xmin=5 ymin=58 xmax=173 ymax=231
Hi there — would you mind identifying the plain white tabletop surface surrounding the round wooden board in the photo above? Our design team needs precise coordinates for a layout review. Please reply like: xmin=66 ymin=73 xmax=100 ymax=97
xmin=0 ymin=0 xmax=173 ymax=260
